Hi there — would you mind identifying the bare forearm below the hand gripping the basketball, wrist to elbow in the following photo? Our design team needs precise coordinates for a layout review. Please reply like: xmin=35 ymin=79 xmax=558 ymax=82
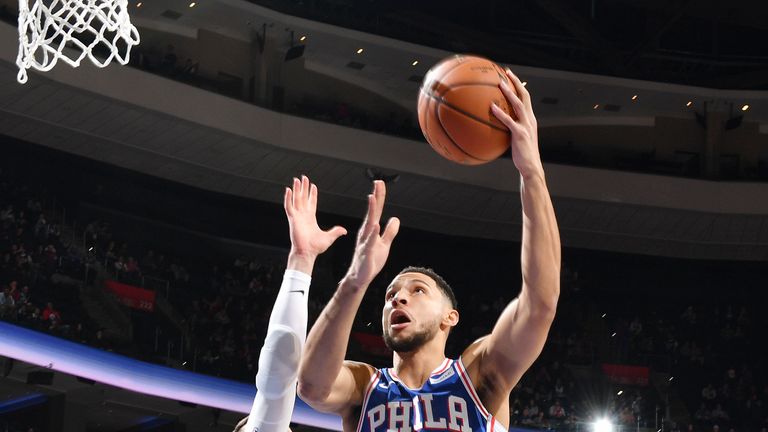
xmin=520 ymin=170 xmax=560 ymax=312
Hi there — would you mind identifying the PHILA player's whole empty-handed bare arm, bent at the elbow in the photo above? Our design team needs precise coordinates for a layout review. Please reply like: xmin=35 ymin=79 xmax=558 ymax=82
xmin=299 ymin=181 xmax=400 ymax=414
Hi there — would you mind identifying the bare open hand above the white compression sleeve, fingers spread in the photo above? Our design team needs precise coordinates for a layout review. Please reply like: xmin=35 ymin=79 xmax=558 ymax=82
xmin=283 ymin=176 xmax=347 ymax=260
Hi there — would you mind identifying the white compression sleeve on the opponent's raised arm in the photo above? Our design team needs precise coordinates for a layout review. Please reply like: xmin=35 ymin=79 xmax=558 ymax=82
xmin=244 ymin=270 xmax=312 ymax=432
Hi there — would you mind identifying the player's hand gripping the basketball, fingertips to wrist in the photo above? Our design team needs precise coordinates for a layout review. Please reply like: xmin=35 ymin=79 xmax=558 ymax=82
xmin=491 ymin=69 xmax=544 ymax=178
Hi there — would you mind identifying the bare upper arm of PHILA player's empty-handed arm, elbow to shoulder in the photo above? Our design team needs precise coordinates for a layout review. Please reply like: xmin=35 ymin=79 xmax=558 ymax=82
xmin=306 ymin=361 xmax=375 ymax=415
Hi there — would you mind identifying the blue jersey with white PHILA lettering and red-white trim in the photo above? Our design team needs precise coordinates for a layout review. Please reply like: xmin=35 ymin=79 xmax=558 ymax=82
xmin=357 ymin=359 xmax=506 ymax=432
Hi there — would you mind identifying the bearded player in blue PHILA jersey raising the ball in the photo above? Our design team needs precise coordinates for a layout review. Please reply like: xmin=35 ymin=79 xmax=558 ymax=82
xmin=298 ymin=71 xmax=560 ymax=432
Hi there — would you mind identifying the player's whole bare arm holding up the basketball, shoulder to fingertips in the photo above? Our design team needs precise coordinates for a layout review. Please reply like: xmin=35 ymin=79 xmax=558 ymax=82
xmin=464 ymin=70 xmax=560 ymax=397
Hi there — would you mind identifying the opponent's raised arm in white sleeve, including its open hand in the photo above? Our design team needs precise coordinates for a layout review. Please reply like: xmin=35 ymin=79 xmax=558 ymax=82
xmin=235 ymin=177 xmax=347 ymax=432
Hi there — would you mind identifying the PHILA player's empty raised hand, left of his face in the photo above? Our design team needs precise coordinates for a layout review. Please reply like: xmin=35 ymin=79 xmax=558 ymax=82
xmin=346 ymin=180 xmax=400 ymax=288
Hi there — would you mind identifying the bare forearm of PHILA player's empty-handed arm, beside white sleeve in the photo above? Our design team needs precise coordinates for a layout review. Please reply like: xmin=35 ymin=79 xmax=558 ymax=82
xmin=299 ymin=278 xmax=367 ymax=401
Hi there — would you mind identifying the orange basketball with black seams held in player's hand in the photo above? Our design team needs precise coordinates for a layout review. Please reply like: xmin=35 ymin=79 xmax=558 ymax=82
xmin=418 ymin=55 xmax=512 ymax=165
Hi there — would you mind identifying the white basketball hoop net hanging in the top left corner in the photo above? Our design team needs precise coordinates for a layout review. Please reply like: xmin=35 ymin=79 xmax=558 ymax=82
xmin=16 ymin=0 xmax=139 ymax=84
